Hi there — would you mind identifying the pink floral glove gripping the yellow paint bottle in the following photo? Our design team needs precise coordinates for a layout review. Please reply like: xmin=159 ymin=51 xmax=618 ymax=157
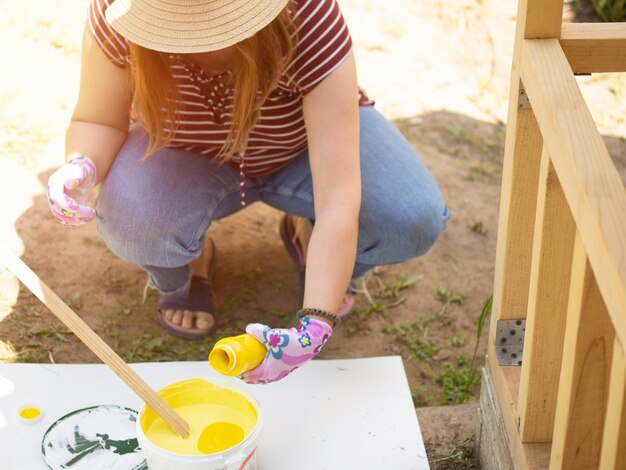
xmin=242 ymin=317 xmax=333 ymax=384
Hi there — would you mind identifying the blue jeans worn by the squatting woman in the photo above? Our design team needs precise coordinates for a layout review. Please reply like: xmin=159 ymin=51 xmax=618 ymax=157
xmin=96 ymin=106 xmax=449 ymax=293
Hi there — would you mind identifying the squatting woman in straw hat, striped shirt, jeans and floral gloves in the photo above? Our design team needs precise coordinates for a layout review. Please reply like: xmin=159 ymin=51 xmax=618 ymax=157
xmin=48 ymin=0 xmax=448 ymax=382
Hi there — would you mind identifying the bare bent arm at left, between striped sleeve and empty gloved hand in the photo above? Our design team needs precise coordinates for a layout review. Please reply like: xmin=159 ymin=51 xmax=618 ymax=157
xmin=65 ymin=26 xmax=132 ymax=183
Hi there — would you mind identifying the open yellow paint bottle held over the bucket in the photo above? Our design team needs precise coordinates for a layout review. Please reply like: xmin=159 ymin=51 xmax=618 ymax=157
xmin=209 ymin=333 xmax=267 ymax=375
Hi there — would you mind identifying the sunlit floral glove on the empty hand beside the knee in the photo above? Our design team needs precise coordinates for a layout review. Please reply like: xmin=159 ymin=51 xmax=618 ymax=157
xmin=46 ymin=157 xmax=96 ymax=227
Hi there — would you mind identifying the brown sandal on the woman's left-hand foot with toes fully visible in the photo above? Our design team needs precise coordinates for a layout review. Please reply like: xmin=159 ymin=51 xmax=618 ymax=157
xmin=157 ymin=238 xmax=217 ymax=339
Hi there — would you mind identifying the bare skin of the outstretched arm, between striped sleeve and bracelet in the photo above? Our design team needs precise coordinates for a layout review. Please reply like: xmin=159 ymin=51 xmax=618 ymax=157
xmin=304 ymin=53 xmax=361 ymax=322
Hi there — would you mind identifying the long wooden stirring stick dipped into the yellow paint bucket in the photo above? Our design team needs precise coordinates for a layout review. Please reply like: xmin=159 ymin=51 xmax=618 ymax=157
xmin=0 ymin=242 xmax=189 ymax=438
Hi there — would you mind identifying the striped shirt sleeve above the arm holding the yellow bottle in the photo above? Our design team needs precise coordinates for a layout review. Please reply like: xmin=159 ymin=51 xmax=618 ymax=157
xmin=287 ymin=0 xmax=352 ymax=94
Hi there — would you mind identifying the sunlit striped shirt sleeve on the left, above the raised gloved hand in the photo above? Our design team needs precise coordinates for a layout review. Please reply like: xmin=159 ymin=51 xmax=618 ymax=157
xmin=88 ymin=0 xmax=129 ymax=68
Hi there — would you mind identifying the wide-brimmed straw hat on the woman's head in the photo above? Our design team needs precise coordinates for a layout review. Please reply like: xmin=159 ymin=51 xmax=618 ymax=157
xmin=106 ymin=0 xmax=289 ymax=54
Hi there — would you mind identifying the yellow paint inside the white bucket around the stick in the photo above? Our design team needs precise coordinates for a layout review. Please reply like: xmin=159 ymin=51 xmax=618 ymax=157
xmin=140 ymin=379 xmax=259 ymax=455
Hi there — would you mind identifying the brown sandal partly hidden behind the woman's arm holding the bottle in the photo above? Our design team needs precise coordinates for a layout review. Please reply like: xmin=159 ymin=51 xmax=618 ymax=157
xmin=280 ymin=214 xmax=356 ymax=320
